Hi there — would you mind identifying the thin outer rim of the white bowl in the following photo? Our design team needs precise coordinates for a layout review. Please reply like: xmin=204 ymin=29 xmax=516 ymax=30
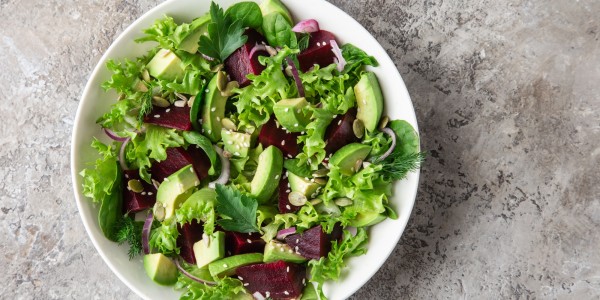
xmin=70 ymin=0 xmax=420 ymax=299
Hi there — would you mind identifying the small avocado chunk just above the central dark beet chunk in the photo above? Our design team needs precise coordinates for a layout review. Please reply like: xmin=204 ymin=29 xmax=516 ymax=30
xmin=273 ymin=97 xmax=311 ymax=132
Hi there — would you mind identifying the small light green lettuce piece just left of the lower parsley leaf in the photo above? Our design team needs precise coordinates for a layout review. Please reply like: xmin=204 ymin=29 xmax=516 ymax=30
xmin=175 ymin=188 xmax=217 ymax=235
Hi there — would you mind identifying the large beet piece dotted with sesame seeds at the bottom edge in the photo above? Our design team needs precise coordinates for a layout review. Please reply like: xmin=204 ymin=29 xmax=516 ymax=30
xmin=236 ymin=260 xmax=306 ymax=299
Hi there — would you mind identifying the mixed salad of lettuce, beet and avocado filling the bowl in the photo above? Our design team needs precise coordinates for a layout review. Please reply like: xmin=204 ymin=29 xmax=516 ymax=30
xmin=78 ymin=0 xmax=424 ymax=299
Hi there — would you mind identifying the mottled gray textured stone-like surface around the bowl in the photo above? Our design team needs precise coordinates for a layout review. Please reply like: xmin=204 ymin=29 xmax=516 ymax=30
xmin=0 ymin=0 xmax=600 ymax=299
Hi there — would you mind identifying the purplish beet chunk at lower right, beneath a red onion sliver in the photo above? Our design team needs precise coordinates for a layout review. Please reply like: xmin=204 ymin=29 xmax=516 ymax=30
xmin=285 ymin=225 xmax=331 ymax=259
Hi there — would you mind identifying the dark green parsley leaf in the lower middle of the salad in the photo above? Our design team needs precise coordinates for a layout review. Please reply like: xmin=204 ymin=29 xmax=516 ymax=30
xmin=216 ymin=184 xmax=258 ymax=232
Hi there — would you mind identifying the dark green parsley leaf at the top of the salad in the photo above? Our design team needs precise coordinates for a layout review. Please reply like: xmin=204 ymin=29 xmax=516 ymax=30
xmin=198 ymin=2 xmax=248 ymax=61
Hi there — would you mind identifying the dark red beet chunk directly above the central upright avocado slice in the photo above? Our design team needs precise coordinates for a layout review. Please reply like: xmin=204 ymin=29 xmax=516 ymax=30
xmin=258 ymin=118 xmax=299 ymax=157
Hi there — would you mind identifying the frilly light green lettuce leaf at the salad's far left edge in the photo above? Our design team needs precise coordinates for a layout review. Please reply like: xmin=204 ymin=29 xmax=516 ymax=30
xmin=79 ymin=138 xmax=120 ymax=203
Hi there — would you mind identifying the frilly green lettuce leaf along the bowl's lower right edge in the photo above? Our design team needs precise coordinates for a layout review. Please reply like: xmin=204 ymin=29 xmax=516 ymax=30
xmin=308 ymin=228 xmax=368 ymax=299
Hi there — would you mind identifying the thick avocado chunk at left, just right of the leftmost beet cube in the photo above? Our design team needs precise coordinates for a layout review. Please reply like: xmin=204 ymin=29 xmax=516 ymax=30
xmin=155 ymin=164 xmax=200 ymax=219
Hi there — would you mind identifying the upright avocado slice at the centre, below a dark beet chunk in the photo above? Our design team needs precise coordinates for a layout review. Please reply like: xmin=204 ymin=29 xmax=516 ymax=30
xmin=250 ymin=146 xmax=283 ymax=203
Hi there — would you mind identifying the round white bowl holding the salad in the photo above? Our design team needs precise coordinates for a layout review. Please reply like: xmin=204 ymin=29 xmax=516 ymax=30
xmin=71 ymin=0 xmax=419 ymax=299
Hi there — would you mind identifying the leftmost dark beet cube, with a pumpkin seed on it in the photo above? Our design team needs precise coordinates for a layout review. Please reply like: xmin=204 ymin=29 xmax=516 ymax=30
xmin=122 ymin=170 xmax=156 ymax=214
